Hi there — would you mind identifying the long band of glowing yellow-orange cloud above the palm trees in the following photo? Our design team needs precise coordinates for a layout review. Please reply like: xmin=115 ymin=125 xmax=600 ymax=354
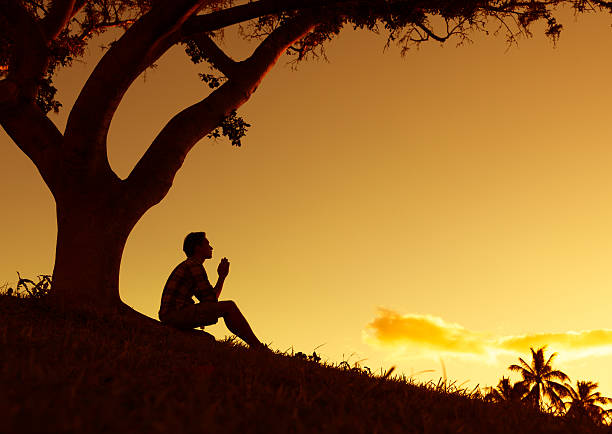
xmin=364 ymin=308 xmax=612 ymax=358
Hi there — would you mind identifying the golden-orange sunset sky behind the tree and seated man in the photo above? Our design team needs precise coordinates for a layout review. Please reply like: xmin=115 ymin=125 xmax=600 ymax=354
xmin=0 ymin=6 xmax=612 ymax=396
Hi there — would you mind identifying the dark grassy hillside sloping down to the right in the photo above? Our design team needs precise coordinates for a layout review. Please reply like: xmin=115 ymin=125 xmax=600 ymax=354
xmin=0 ymin=296 xmax=607 ymax=434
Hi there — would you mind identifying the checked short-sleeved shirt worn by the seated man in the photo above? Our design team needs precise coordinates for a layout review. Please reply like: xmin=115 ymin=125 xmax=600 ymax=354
xmin=159 ymin=258 xmax=217 ymax=319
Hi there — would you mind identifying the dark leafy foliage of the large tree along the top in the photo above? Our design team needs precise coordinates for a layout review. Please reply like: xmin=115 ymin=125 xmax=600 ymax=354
xmin=0 ymin=0 xmax=612 ymax=136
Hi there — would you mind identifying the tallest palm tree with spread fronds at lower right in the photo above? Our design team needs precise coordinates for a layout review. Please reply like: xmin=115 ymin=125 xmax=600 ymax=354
xmin=508 ymin=346 xmax=569 ymax=412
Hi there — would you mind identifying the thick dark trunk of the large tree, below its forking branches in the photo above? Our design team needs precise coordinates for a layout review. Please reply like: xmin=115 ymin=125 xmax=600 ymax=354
xmin=50 ymin=188 xmax=142 ymax=311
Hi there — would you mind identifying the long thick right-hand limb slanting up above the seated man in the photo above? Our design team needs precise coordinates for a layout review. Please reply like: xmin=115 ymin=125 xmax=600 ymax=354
xmin=126 ymin=14 xmax=316 ymax=212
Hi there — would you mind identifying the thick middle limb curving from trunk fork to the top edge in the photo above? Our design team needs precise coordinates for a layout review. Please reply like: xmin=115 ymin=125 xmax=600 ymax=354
xmin=65 ymin=0 xmax=205 ymax=173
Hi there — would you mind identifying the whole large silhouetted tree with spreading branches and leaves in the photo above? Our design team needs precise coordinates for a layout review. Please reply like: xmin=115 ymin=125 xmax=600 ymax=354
xmin=0 ymin=0 xmax=610 ymax=309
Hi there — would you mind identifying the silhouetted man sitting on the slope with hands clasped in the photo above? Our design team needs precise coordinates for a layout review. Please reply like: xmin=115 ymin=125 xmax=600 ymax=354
xmin=159 ymin=232 xmax=265 ymax=348
